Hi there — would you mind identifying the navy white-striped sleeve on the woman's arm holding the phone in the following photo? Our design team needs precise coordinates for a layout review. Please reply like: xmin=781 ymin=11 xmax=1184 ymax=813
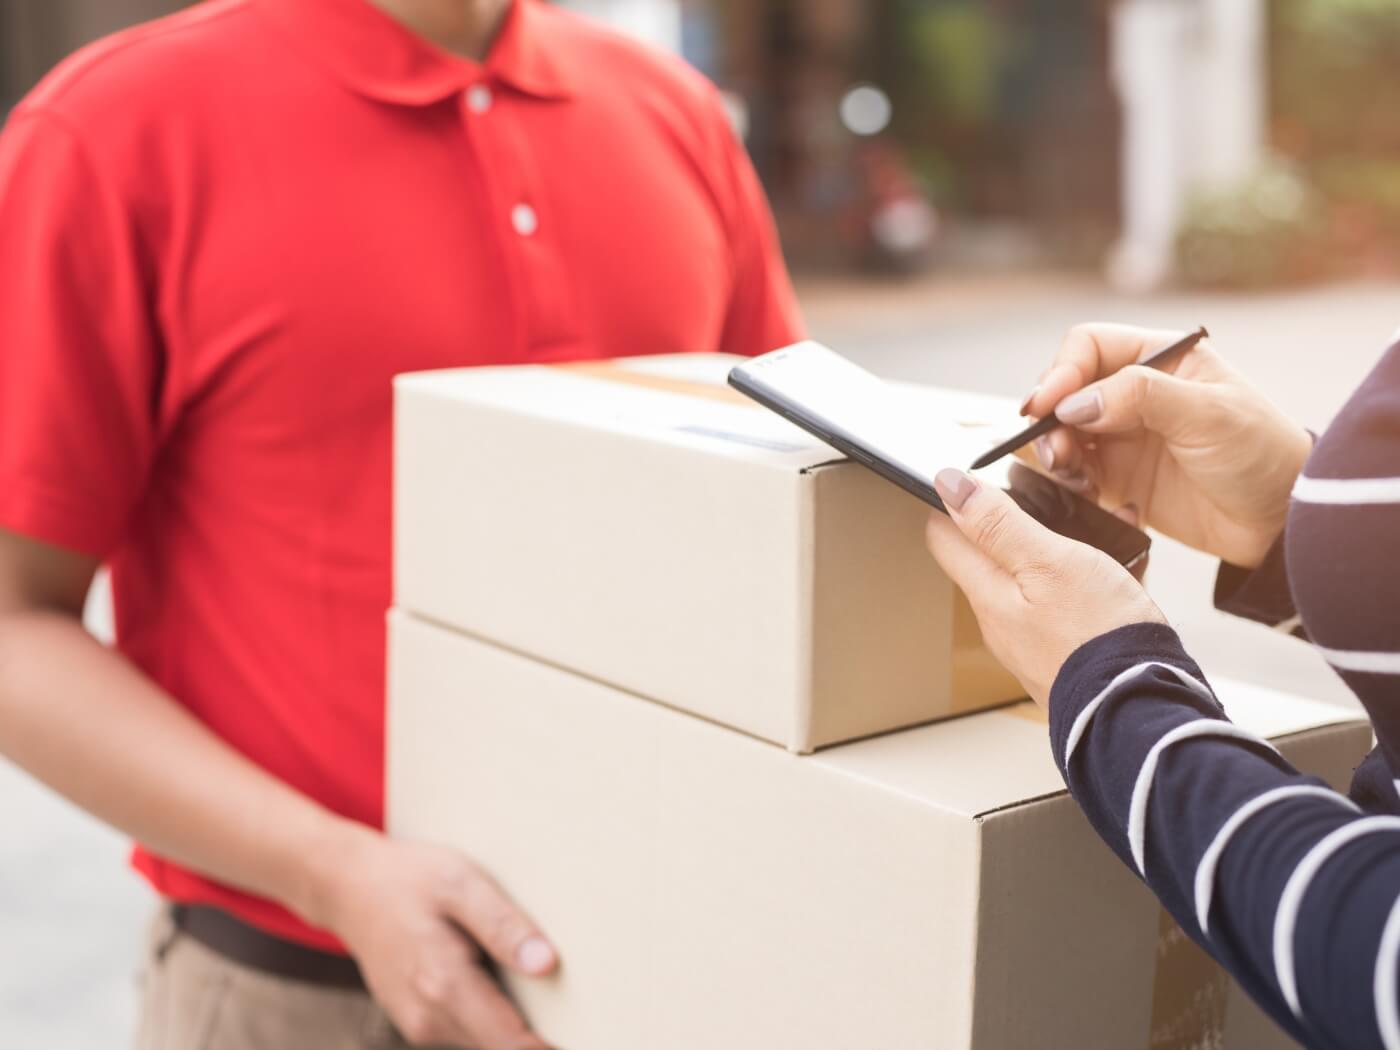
xmin=1050 ymin=624 xmax=1400 ymax=1050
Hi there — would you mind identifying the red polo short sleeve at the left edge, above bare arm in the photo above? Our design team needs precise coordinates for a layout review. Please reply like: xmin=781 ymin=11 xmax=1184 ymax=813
xmin=0 ymin=109 xmax=160 ymax=557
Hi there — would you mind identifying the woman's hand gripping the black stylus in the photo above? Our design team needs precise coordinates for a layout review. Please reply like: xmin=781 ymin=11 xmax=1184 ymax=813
xmin=1022 ymin=325 xmax=1312 ymax=568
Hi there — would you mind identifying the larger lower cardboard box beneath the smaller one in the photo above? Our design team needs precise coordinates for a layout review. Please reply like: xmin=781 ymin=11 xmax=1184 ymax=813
xmin=388 ymin=613 xmax=1371 ymax=1050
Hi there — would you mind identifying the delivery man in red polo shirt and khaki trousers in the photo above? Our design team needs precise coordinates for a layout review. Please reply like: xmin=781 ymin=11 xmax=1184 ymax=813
xmin=0 ymin=0 xmax=799 ymax=1050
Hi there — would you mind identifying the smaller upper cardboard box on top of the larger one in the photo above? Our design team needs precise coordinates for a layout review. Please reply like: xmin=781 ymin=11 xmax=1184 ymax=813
xmin=395 ymin=354 xmax=1023 ymax=752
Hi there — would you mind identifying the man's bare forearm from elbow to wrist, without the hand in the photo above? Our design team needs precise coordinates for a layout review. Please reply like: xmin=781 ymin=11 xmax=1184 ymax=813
xmin=0 ymin=610 xmax=365 ymax=924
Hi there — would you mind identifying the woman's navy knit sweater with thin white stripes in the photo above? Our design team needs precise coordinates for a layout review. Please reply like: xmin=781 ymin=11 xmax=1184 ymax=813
xmin=1050 ymin=343 xmax=1400 ymax=1050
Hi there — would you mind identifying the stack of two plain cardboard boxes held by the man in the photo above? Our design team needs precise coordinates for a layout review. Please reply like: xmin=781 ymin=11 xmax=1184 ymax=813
xmin=388 ymin=356 xmax=1369 ymax=1050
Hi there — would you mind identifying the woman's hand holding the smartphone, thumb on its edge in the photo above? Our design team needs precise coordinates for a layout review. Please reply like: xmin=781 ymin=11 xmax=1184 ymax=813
xmin=928 ymin=470 xmax=1165 ymax=706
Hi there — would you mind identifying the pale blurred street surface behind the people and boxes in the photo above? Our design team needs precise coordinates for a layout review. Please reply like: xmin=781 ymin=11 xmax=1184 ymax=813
xmin=0 ymin=274 xmax=1400 ymax=1050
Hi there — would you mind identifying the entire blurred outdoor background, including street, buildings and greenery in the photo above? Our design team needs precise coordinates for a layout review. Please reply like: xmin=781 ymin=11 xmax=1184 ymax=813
xmin=0 ymin=0 xmax=1400 ymax=1050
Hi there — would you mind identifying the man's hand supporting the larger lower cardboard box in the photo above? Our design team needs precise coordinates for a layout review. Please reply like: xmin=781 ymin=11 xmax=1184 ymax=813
xmin=318 ymin=832 xmax=559 ymax=1050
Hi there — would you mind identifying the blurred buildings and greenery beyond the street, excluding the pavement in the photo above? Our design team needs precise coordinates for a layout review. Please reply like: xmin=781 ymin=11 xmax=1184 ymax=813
xmin=8 ymin=0 xmax=1400 ymax=290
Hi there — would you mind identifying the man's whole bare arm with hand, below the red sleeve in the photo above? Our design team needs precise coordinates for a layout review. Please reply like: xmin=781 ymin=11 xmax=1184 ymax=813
xmin=0 ymin=531 xmax=554 ymax=1050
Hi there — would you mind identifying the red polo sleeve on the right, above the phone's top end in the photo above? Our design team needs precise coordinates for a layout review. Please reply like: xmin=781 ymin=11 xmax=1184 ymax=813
xmin=714 ymin=92 xmax=804 ymax=357
